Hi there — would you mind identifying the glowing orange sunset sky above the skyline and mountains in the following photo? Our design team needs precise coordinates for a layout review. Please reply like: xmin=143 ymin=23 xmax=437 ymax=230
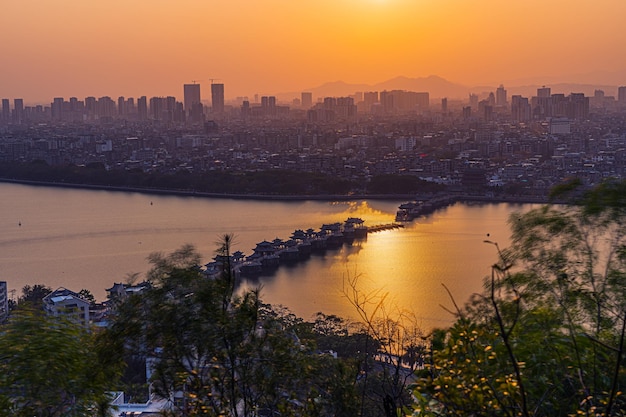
xmin=0 ymin=0 xmax=626 ymax=103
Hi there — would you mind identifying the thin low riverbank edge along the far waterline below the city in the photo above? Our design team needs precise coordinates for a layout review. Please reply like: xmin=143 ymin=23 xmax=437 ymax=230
xmin=0 ymin=178 xmax=548 ymax=204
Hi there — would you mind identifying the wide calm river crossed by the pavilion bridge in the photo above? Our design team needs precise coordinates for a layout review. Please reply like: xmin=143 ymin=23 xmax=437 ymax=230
xmin=0 ymin=183 xmax=532 ymax=328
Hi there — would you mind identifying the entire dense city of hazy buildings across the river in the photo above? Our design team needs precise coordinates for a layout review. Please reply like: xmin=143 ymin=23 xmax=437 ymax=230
xmin=0 ymin=84 xmax=626 ymax=194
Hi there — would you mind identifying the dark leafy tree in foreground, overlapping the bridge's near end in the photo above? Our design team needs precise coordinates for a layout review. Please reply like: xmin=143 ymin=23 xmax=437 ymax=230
xmin=108 ymin=239 xmax=355 ymax=416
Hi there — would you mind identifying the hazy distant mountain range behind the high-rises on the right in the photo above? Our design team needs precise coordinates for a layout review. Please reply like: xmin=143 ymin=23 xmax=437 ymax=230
xmin=277 ymin=71 xmax=626 ymax=101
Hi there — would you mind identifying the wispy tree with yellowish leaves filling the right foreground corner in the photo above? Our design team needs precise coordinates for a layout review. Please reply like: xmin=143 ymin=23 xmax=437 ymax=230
xmin=415 ymin=177 xmax=626 ymax=416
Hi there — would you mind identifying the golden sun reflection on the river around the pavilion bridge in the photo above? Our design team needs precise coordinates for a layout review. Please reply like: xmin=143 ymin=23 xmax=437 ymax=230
xmin=254 ymin=203 xmax=512 ymax=328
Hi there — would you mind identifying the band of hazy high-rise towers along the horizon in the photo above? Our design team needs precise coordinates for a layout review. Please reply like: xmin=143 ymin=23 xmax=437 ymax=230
xmin=0 ymin=79 xmax=626 ymax=125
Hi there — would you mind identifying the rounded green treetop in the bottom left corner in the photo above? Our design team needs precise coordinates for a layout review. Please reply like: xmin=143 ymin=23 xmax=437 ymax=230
xmin=0 ymin=308 xmax=120 ymax=417
